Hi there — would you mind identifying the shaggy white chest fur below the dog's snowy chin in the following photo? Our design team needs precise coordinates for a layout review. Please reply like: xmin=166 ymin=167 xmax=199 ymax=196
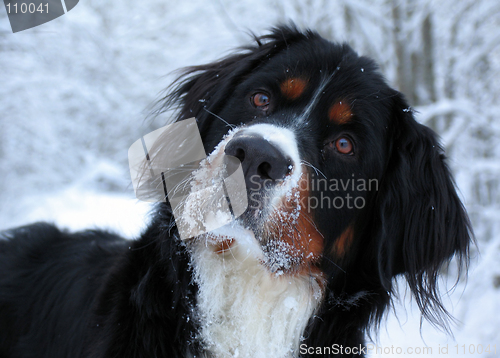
xmin=191 ymin=229 xmax=322 ymax=358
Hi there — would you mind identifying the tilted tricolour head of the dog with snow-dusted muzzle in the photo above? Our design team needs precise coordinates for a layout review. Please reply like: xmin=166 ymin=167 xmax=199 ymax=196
xmin=156 ymin=27 xmax=471 ymax=328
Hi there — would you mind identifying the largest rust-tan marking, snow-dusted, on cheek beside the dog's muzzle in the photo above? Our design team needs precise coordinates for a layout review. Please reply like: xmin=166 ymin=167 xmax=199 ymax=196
xmin=268 ymin=169 xmax=324 ymax=277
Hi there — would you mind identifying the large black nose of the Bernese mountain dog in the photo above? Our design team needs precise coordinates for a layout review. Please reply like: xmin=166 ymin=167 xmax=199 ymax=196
xmin=225 ymin=132 xmax=292 ymax=190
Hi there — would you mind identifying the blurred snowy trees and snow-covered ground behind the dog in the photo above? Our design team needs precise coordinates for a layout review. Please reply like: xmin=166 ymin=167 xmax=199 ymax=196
xmin=0 ymin=0 xmax=500 ymax=357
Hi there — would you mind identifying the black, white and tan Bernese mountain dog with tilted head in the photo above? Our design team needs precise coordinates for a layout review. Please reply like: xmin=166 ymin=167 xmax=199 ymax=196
xmin=0 ymin=25 xmax=474 ymax=358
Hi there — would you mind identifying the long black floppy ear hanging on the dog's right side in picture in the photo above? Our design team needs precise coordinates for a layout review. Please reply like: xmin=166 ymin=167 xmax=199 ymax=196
xmin=377 ymin=92 xmax=473 ymax=329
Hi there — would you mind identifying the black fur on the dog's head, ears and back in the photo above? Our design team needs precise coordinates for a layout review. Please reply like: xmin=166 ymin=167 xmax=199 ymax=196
xmin=0 ymin=27 xmax=472 ymax=358
